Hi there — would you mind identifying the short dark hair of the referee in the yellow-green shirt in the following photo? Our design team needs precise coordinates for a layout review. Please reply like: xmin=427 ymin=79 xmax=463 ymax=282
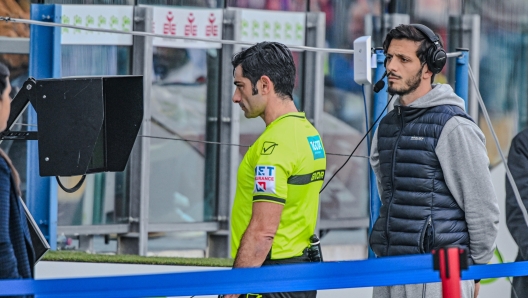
xmin=231 ymin=41 xmax=295 ymax=100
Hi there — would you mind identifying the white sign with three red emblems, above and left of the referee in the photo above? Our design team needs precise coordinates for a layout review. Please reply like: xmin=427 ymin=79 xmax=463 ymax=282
xmin=152 ymin=6 xmax=223 ymax=49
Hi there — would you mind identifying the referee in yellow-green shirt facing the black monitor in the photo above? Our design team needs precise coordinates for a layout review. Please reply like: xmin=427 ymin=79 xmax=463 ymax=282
xmin=220 ymin=42 xmax=326 ymax=298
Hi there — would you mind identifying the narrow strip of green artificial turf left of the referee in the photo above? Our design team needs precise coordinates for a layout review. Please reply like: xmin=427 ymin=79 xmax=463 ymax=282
xmin=41 ymin=251 xmax=233 ymax=267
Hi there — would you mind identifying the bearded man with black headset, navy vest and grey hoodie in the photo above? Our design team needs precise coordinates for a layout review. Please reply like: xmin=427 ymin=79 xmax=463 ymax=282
xmin=369 ymin=24 xmax=499 ymax=298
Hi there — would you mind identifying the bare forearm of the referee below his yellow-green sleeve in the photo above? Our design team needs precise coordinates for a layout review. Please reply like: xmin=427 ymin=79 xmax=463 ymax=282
xmin=233 ymin=202 xmax=284 ymax=268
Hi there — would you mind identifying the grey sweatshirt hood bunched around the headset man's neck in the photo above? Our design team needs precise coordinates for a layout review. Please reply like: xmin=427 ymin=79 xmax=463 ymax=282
xmin=394 ymin=84 xmax=466 ymax=111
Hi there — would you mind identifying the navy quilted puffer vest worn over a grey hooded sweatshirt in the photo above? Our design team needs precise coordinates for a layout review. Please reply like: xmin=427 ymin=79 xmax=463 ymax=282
xmin=370 ymin=105 xmax=473 ymax=256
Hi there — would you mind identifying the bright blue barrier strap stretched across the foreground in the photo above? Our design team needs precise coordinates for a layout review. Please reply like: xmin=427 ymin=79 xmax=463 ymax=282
xmin=0 ymin=255 xmax=528 ymax=297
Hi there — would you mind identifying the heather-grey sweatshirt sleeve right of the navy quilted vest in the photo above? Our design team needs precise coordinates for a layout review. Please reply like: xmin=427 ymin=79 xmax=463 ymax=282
xmin=435 ymin=117 xmax=499 ymax=264
